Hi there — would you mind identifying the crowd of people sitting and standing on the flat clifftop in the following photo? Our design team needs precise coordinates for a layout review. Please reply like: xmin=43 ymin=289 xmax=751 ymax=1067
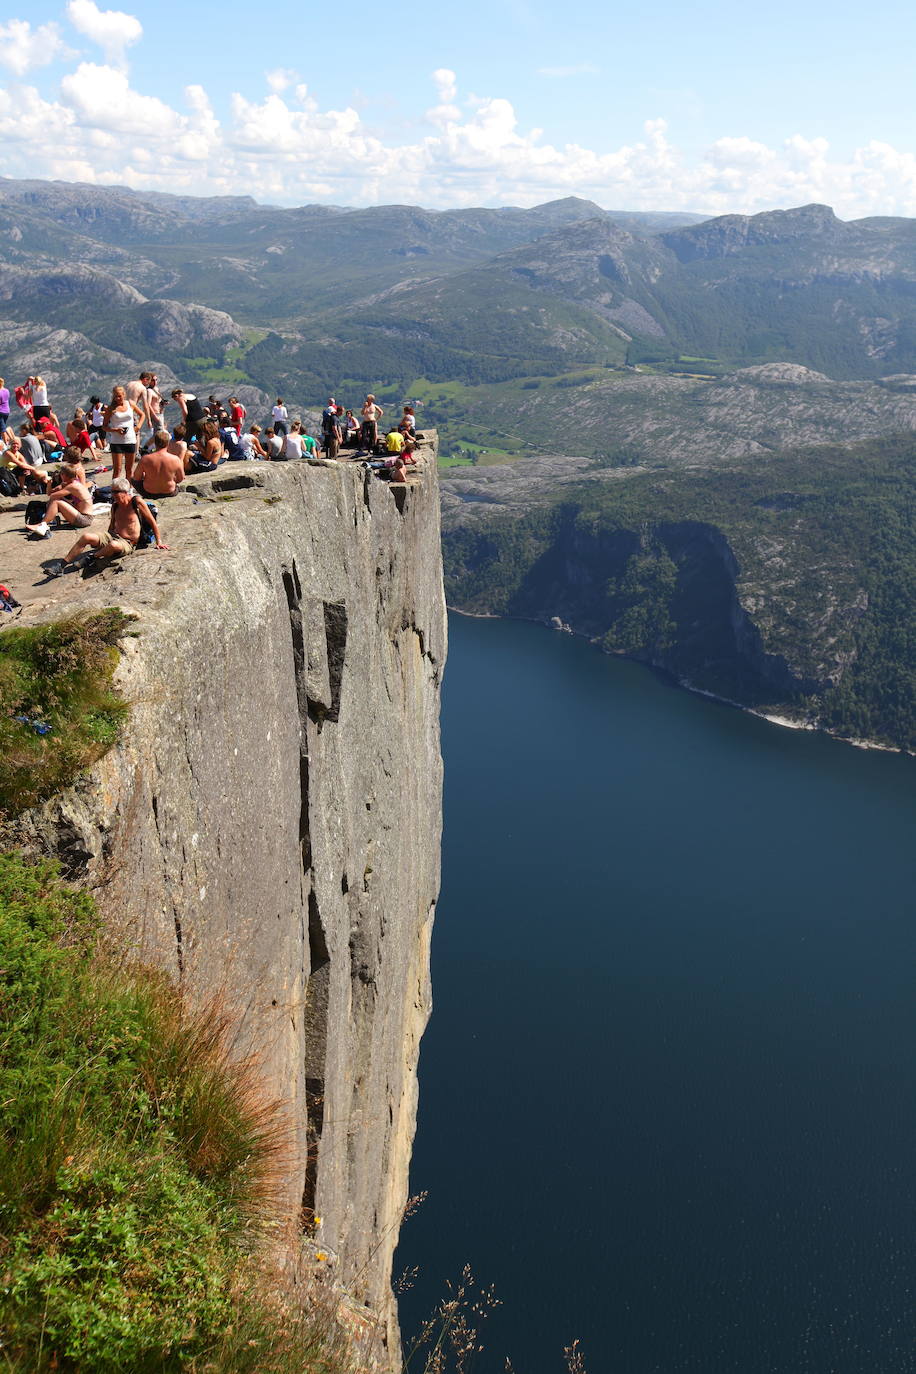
xmin=0 ymin=371 xmax=417 ymax=576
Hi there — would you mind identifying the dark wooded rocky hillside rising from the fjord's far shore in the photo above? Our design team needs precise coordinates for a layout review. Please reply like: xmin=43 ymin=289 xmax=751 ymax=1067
xmin=442 ymin=436 xmax=916 ymax=749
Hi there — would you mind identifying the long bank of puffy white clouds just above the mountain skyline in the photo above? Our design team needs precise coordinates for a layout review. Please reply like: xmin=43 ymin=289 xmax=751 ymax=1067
xmin=7 ymin=32 xmax=916 ymax=218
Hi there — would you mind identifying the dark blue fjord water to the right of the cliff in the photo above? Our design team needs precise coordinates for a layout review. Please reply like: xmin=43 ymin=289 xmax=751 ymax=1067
xmin=398 ymin=617 xmax=916 ymax=1374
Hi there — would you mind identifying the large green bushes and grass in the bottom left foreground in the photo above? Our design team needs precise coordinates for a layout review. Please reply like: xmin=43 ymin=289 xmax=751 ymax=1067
xmin=0 ymin=855 xmax=346 ymax=1374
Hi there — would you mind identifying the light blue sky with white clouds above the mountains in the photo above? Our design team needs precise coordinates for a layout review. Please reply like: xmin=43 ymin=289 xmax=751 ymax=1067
xmin=0 ymin=0 xmax=916 ymax=218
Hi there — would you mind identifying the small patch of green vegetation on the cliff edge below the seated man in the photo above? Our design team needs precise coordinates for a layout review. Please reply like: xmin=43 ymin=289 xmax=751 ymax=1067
xmin=0 ymin=610 xmax=129 ymax=816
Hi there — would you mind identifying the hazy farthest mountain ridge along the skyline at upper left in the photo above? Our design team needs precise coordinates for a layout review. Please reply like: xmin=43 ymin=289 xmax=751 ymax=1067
xmin=0 ymin=179 xmax=691 ymax=316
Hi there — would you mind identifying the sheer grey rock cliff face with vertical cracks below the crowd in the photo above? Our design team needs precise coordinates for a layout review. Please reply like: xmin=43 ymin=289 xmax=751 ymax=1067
xmin=9 ymin=444 xmax=446 ymax=1363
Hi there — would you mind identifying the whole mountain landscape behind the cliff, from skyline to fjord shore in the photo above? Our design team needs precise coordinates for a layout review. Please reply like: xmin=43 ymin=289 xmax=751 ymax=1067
xmin=0 ymin=180 xmax=916 ymax=749
